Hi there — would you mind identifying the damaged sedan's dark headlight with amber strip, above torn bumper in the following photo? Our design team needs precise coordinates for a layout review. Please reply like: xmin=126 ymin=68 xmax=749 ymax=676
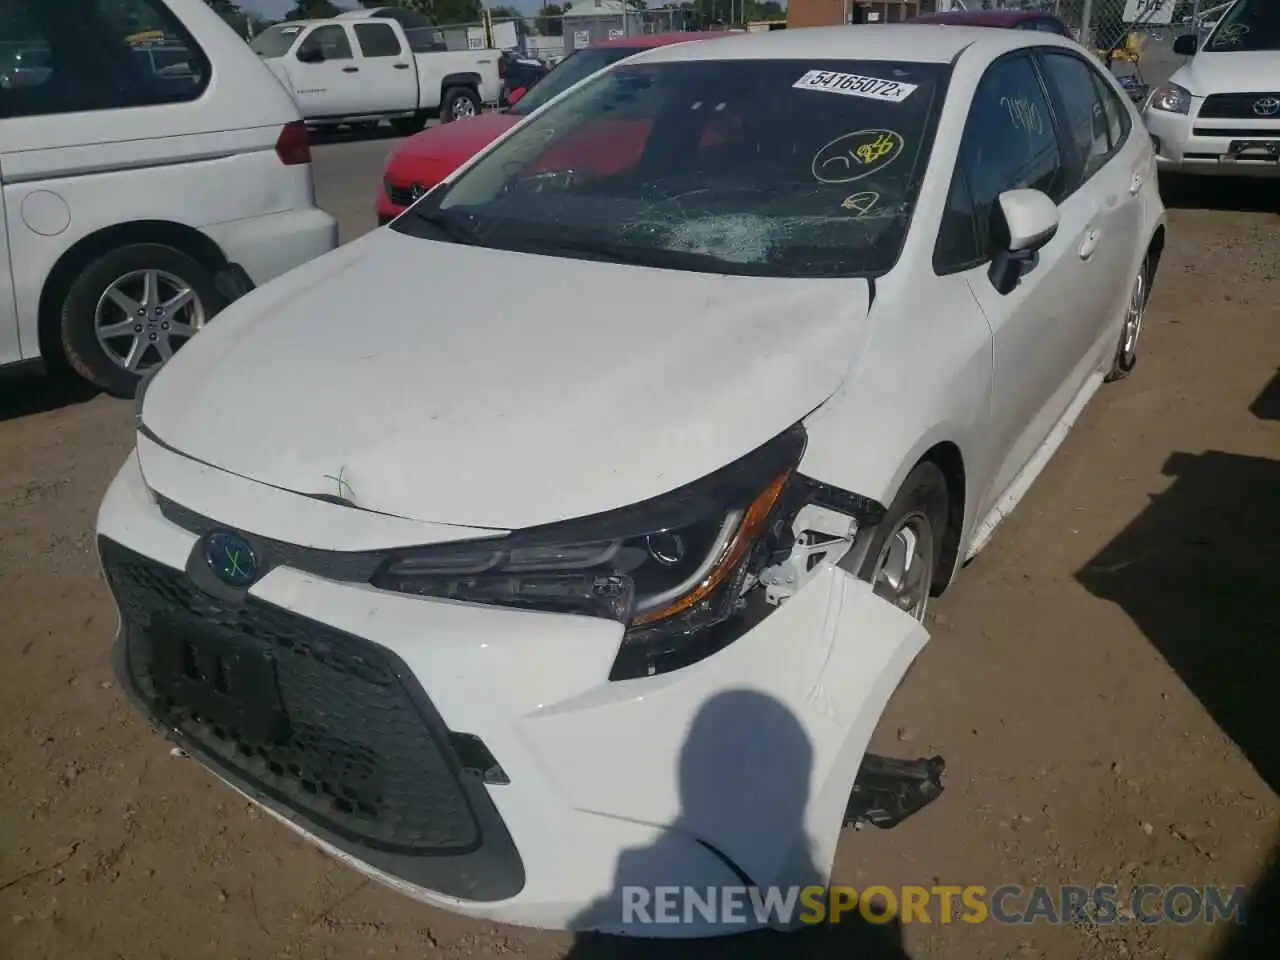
xmin=371 ymin=426 xmax=805 ymax=676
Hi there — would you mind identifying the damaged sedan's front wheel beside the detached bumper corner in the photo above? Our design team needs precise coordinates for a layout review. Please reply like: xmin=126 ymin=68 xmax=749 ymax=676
xmin=858 ymin=462 xmax=948 ymax=621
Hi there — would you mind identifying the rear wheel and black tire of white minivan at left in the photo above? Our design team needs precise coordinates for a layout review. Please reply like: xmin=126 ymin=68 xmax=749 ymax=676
xmin=59 ymin=243 xmax=227 ymax=397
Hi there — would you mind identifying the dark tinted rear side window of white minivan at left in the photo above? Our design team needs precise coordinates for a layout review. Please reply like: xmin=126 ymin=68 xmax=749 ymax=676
xmin=0 ymin=0 xmax=210 ymax=118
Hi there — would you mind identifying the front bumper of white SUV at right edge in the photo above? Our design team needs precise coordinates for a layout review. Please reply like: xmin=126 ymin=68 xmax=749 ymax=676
xmin=1143 ymin=99 xmax=1280 ymax=177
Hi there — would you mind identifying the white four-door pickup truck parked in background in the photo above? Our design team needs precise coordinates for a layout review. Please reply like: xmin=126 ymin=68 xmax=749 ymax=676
xmin=251 ymin=9 xmax=502 ymax=136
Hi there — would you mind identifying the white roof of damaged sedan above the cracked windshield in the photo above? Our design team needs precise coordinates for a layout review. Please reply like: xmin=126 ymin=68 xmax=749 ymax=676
xmin=624 ymin=23 xmax=1066 ymax=64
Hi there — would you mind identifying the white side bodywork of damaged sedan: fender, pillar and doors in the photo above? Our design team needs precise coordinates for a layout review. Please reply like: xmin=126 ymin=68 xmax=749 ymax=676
xmin=788 ymin=27 xmax=1166 ymax=570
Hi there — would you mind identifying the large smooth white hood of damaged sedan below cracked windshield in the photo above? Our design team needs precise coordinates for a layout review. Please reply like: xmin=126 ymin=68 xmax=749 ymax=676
xmin=142 ymin=229 xmax=869 ymax=530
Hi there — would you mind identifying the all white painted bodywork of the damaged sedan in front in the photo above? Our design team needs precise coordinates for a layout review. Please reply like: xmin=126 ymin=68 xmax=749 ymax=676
xmin=99 ymin=26 xmax=1165 ymax=936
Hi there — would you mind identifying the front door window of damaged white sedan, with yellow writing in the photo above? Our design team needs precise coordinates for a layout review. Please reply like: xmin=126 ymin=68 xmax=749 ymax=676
xmin=960 ymin=55 xmax=1068 ymax=252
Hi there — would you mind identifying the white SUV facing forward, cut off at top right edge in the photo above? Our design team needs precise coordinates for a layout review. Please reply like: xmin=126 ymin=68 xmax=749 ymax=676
xmin=1143 ymin=0 xmax=1280 ymax=177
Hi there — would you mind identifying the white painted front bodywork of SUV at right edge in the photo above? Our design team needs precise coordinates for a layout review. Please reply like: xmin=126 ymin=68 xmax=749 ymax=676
xmin=1143 ymin=31 xmax=1280 ymax=177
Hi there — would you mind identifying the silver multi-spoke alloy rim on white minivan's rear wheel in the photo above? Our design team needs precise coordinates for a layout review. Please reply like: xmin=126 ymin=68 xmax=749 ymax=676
xmin=93 ymin=270 xmax=207 ymax=374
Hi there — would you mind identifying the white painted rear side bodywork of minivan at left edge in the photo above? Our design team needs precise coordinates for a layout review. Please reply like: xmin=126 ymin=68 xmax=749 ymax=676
xmin=0 ymin=0 xmax=338 ymax=366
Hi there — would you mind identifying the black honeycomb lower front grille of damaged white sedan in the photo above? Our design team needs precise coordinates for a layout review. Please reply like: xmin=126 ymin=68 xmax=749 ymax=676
xmin=101 ymin=540 xmax=481 ymax=856
